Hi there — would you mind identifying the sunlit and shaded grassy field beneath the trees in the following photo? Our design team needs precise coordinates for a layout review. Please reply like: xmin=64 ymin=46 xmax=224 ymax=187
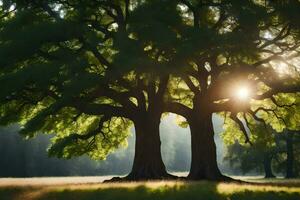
xmin=0 ymin=177 xmax=300 ymax=200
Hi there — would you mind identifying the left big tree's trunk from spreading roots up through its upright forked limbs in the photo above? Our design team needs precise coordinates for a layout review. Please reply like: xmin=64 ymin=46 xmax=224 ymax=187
xmin=108 ymin=76 xmax=172 ymax=181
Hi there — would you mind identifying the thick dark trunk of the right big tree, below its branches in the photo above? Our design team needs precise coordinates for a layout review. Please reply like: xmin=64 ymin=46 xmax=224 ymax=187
xmin=188 ymin=112 xmax=227 ymax=180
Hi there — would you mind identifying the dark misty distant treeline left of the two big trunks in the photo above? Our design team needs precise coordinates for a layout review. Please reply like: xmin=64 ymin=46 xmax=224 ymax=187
xmin=0 ymin=127 xmax=132 ymax=177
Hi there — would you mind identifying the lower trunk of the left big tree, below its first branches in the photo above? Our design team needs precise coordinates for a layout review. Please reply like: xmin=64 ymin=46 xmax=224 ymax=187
xmin=125 ymin=116 xmax=172 ymax=180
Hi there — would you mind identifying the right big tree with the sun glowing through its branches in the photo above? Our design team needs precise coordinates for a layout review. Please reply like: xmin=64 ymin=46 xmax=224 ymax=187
xmin=166 ymin=0 xmax=300 ymax=180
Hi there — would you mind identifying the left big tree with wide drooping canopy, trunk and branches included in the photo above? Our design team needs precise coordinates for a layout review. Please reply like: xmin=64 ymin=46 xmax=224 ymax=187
xmin=0 ymin=0 xmax=180 ymax=180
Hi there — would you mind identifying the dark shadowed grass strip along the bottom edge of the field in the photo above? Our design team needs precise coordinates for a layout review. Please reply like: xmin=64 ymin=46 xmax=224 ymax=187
xmin=0 ymin=182 xmax=300 ymax=200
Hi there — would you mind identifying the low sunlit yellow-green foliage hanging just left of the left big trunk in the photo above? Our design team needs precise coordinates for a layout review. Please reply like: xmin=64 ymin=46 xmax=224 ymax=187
xmin=49 ymin=116 xmax=131 ymax=160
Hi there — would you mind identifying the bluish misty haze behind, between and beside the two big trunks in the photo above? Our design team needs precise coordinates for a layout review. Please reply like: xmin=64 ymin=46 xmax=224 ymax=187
xmin=0 ymin=114 xmax=234 ymax=177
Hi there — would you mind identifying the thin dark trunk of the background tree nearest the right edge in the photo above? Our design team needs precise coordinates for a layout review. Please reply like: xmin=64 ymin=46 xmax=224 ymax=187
xmin=286 ymin=132 xmax=295 ymax=178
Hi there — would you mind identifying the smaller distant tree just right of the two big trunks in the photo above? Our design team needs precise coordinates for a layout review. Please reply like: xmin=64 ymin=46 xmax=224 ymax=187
xmin=222 ymin=123 xmax=283 ymax=178
